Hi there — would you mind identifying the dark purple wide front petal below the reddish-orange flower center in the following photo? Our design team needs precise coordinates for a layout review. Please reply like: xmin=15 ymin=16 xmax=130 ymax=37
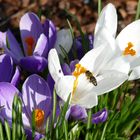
xmin=20 ymin=56 xmax=47 ymax=73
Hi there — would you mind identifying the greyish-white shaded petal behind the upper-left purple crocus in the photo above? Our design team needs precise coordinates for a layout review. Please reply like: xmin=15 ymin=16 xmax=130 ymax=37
xmin=54 ymin=29 xmax=73 ymax=57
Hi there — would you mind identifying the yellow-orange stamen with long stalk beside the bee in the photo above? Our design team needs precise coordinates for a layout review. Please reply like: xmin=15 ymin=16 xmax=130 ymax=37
xmin=72 ymin=64 xmax=87 ymax=96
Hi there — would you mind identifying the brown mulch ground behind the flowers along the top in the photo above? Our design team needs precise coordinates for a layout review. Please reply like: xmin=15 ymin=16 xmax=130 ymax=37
xmin=0 ymin=0 xmax=137 ymax=34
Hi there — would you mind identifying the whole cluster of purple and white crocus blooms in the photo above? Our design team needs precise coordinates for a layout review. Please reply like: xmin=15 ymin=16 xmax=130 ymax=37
xmin=0 ymin=4 xmax=140 ymax=139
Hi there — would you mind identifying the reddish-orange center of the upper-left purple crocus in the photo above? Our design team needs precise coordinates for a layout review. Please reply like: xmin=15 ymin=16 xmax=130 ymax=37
xmin=25 ymin=37 xmax=35 ymax=56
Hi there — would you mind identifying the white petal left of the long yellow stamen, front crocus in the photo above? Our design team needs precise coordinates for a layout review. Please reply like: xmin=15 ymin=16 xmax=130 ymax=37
xmin=55 ymin=76 xmax=75 ymax=102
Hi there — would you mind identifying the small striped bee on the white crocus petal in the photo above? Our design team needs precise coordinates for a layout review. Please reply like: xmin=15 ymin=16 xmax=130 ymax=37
xmin=85 ymin=70 xmax=97 ymax=86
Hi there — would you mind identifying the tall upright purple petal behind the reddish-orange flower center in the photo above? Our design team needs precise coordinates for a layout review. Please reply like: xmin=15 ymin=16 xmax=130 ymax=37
xmin=19 ymin=12 xmax=43 ymax=55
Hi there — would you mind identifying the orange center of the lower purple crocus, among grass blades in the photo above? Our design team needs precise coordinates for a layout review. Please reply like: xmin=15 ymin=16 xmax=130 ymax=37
xmin=35 ymin=109 xmax=44 ymax=128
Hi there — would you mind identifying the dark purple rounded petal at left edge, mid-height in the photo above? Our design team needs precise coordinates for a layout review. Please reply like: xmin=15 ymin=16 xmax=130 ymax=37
xmin=0 ymin=54 xmax=13 ymax=82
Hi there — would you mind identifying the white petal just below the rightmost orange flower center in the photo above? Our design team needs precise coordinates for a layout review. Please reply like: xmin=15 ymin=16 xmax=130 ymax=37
xmin=103 ymin=57 xmax=130 ymax=74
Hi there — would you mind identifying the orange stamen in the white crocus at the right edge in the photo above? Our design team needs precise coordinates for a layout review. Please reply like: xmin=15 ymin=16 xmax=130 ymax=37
xmin=123 ymin=42 xmax=136 ymax=56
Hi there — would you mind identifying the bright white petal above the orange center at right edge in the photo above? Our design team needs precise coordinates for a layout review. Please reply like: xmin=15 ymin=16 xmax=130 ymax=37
xmin=116 ymin=20 xmax=140 ymax=52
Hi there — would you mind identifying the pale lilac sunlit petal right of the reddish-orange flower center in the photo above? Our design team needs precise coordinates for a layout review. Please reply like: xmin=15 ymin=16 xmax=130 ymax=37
xmin=33 ymin=34 xmax=49 ymax=57
